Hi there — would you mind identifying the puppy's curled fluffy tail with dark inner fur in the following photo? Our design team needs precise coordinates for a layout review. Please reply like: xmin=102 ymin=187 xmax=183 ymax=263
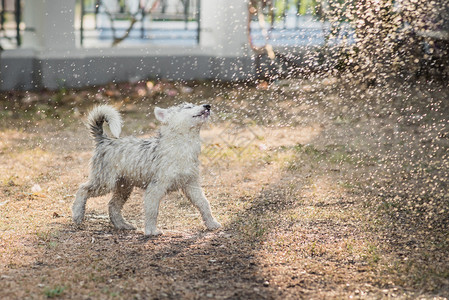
xmin=87 ymin=105 xmax=122 ymax=142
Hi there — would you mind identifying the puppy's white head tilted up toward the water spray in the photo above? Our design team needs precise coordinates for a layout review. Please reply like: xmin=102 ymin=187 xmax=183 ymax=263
xmin=154 ymin=103 xmax=211 ymax=132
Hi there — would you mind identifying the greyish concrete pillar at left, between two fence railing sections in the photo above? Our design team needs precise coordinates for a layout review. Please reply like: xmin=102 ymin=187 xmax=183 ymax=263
xmin=22 ymin=0 xmax=76 ymax=51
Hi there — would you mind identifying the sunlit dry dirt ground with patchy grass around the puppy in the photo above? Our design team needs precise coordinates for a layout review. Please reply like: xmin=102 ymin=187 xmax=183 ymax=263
xmin=0 ymin=77 xmax=449 ymax=299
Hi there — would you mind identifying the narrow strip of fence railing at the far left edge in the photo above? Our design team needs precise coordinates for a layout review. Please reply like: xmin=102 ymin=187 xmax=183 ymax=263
xmin=0 ymin=0 xmax=22 ymax=48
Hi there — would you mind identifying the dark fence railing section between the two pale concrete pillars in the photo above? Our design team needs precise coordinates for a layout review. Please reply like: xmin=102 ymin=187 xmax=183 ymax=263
xmin=79 ymin=0 xmax=200 ymax=46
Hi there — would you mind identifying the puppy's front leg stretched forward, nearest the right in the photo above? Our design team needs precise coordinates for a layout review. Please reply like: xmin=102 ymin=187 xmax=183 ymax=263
xmin=183 ymin=181 xmax=221 ymax=230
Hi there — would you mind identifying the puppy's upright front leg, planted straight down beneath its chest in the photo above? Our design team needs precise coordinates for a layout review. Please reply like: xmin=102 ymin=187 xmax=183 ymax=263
xmin=144 ymin=183 xmax=166 ymax=235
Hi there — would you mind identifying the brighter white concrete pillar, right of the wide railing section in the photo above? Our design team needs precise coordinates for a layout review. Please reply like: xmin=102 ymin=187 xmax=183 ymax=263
xmin=200 ymin=0 xmax=249 ymax=57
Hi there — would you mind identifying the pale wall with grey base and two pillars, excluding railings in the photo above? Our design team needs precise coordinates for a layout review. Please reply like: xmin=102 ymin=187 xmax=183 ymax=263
xmin=0 ymin=0 xmax=254 ymax=90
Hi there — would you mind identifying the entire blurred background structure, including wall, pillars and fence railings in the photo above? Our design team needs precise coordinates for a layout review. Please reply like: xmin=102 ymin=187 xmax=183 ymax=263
xmin=0 ymin=0 xmax=449 ymax=90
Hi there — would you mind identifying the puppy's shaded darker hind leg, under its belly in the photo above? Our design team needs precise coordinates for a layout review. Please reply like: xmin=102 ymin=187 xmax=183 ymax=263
xmin=109 ymin=180 xmax=136 ymax=230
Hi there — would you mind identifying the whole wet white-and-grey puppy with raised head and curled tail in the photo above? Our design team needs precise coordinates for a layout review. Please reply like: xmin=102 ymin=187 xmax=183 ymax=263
xmin=72 ymin=103 xmax=221 ymax=235
